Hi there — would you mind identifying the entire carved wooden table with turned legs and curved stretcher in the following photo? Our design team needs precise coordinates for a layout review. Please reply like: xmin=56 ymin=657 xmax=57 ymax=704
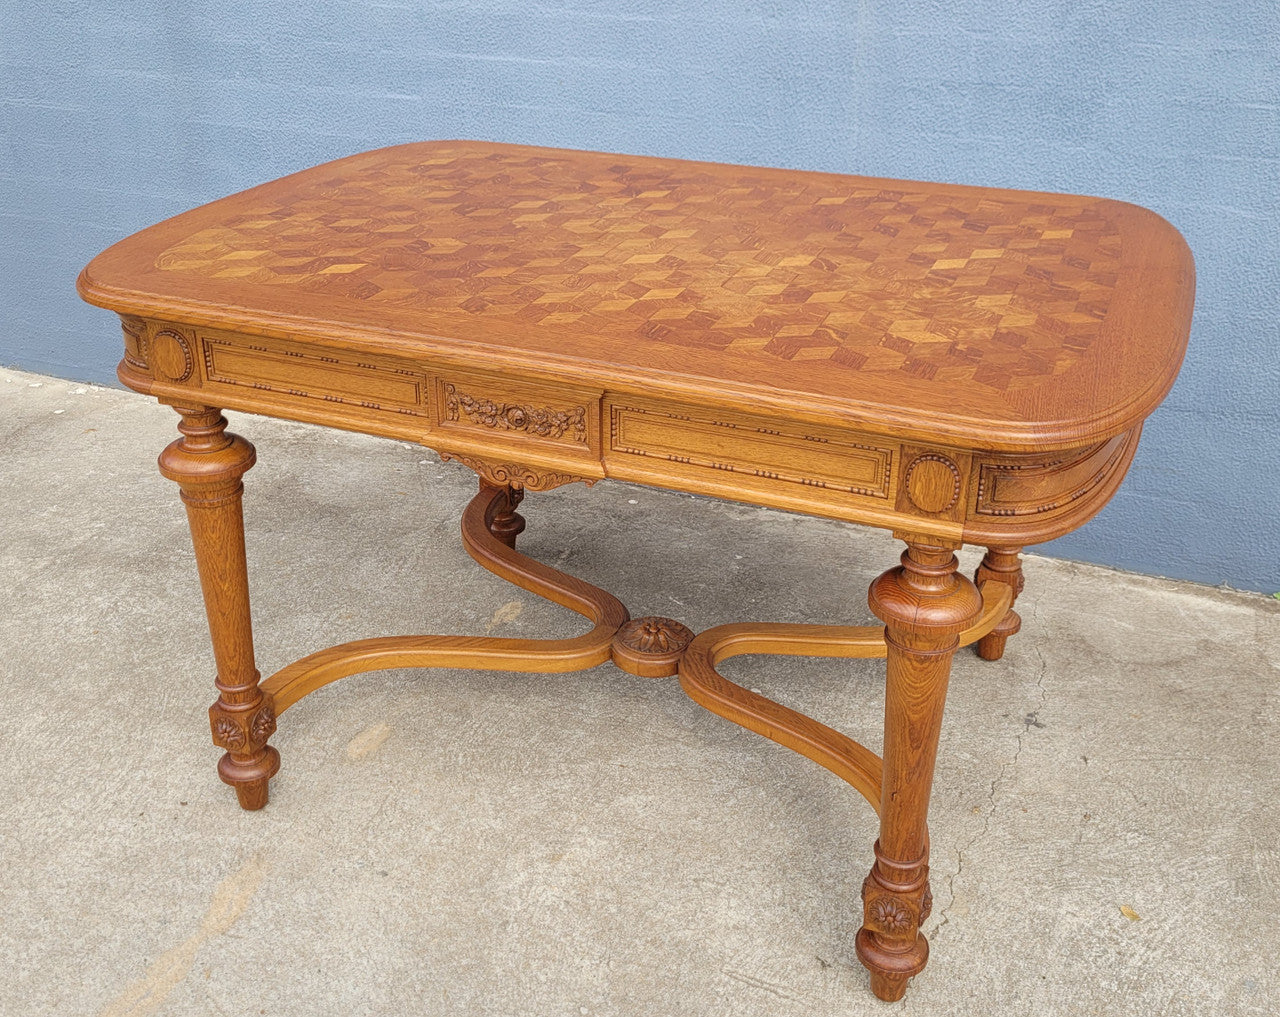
xmin=78 ymin=142 xmax=1194 ymax=999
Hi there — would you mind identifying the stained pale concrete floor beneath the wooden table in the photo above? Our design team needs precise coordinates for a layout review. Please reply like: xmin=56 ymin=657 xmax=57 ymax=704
xmin=0 ymin=370 xmax=1280 ymax=1017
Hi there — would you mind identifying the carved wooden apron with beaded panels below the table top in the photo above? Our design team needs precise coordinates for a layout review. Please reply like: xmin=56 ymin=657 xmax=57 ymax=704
xmin=119 ymin=316 xmax=1140 ymax=546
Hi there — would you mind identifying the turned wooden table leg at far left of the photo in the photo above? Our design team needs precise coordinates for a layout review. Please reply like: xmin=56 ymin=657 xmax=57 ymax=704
xmin=160 ymin=406 xmax=280 ymax=808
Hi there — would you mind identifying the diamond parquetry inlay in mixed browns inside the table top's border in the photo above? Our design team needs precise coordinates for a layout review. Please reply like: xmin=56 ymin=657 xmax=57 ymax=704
xmin=156 ymin=142 xmax=1121 ymax=390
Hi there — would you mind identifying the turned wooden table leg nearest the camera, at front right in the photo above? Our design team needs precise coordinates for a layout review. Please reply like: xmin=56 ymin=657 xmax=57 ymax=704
xmin=858 ymin=541 xmax=982 ymax=1000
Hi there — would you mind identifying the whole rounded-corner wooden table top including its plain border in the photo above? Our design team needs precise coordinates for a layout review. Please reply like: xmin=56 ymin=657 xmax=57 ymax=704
xmin=81 ymin=141 xmax=1194 ymax=449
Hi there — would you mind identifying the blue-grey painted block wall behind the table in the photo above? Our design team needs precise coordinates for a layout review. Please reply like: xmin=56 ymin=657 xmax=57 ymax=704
xmin=0 ymin=0 xmax=1280 ymax=591
